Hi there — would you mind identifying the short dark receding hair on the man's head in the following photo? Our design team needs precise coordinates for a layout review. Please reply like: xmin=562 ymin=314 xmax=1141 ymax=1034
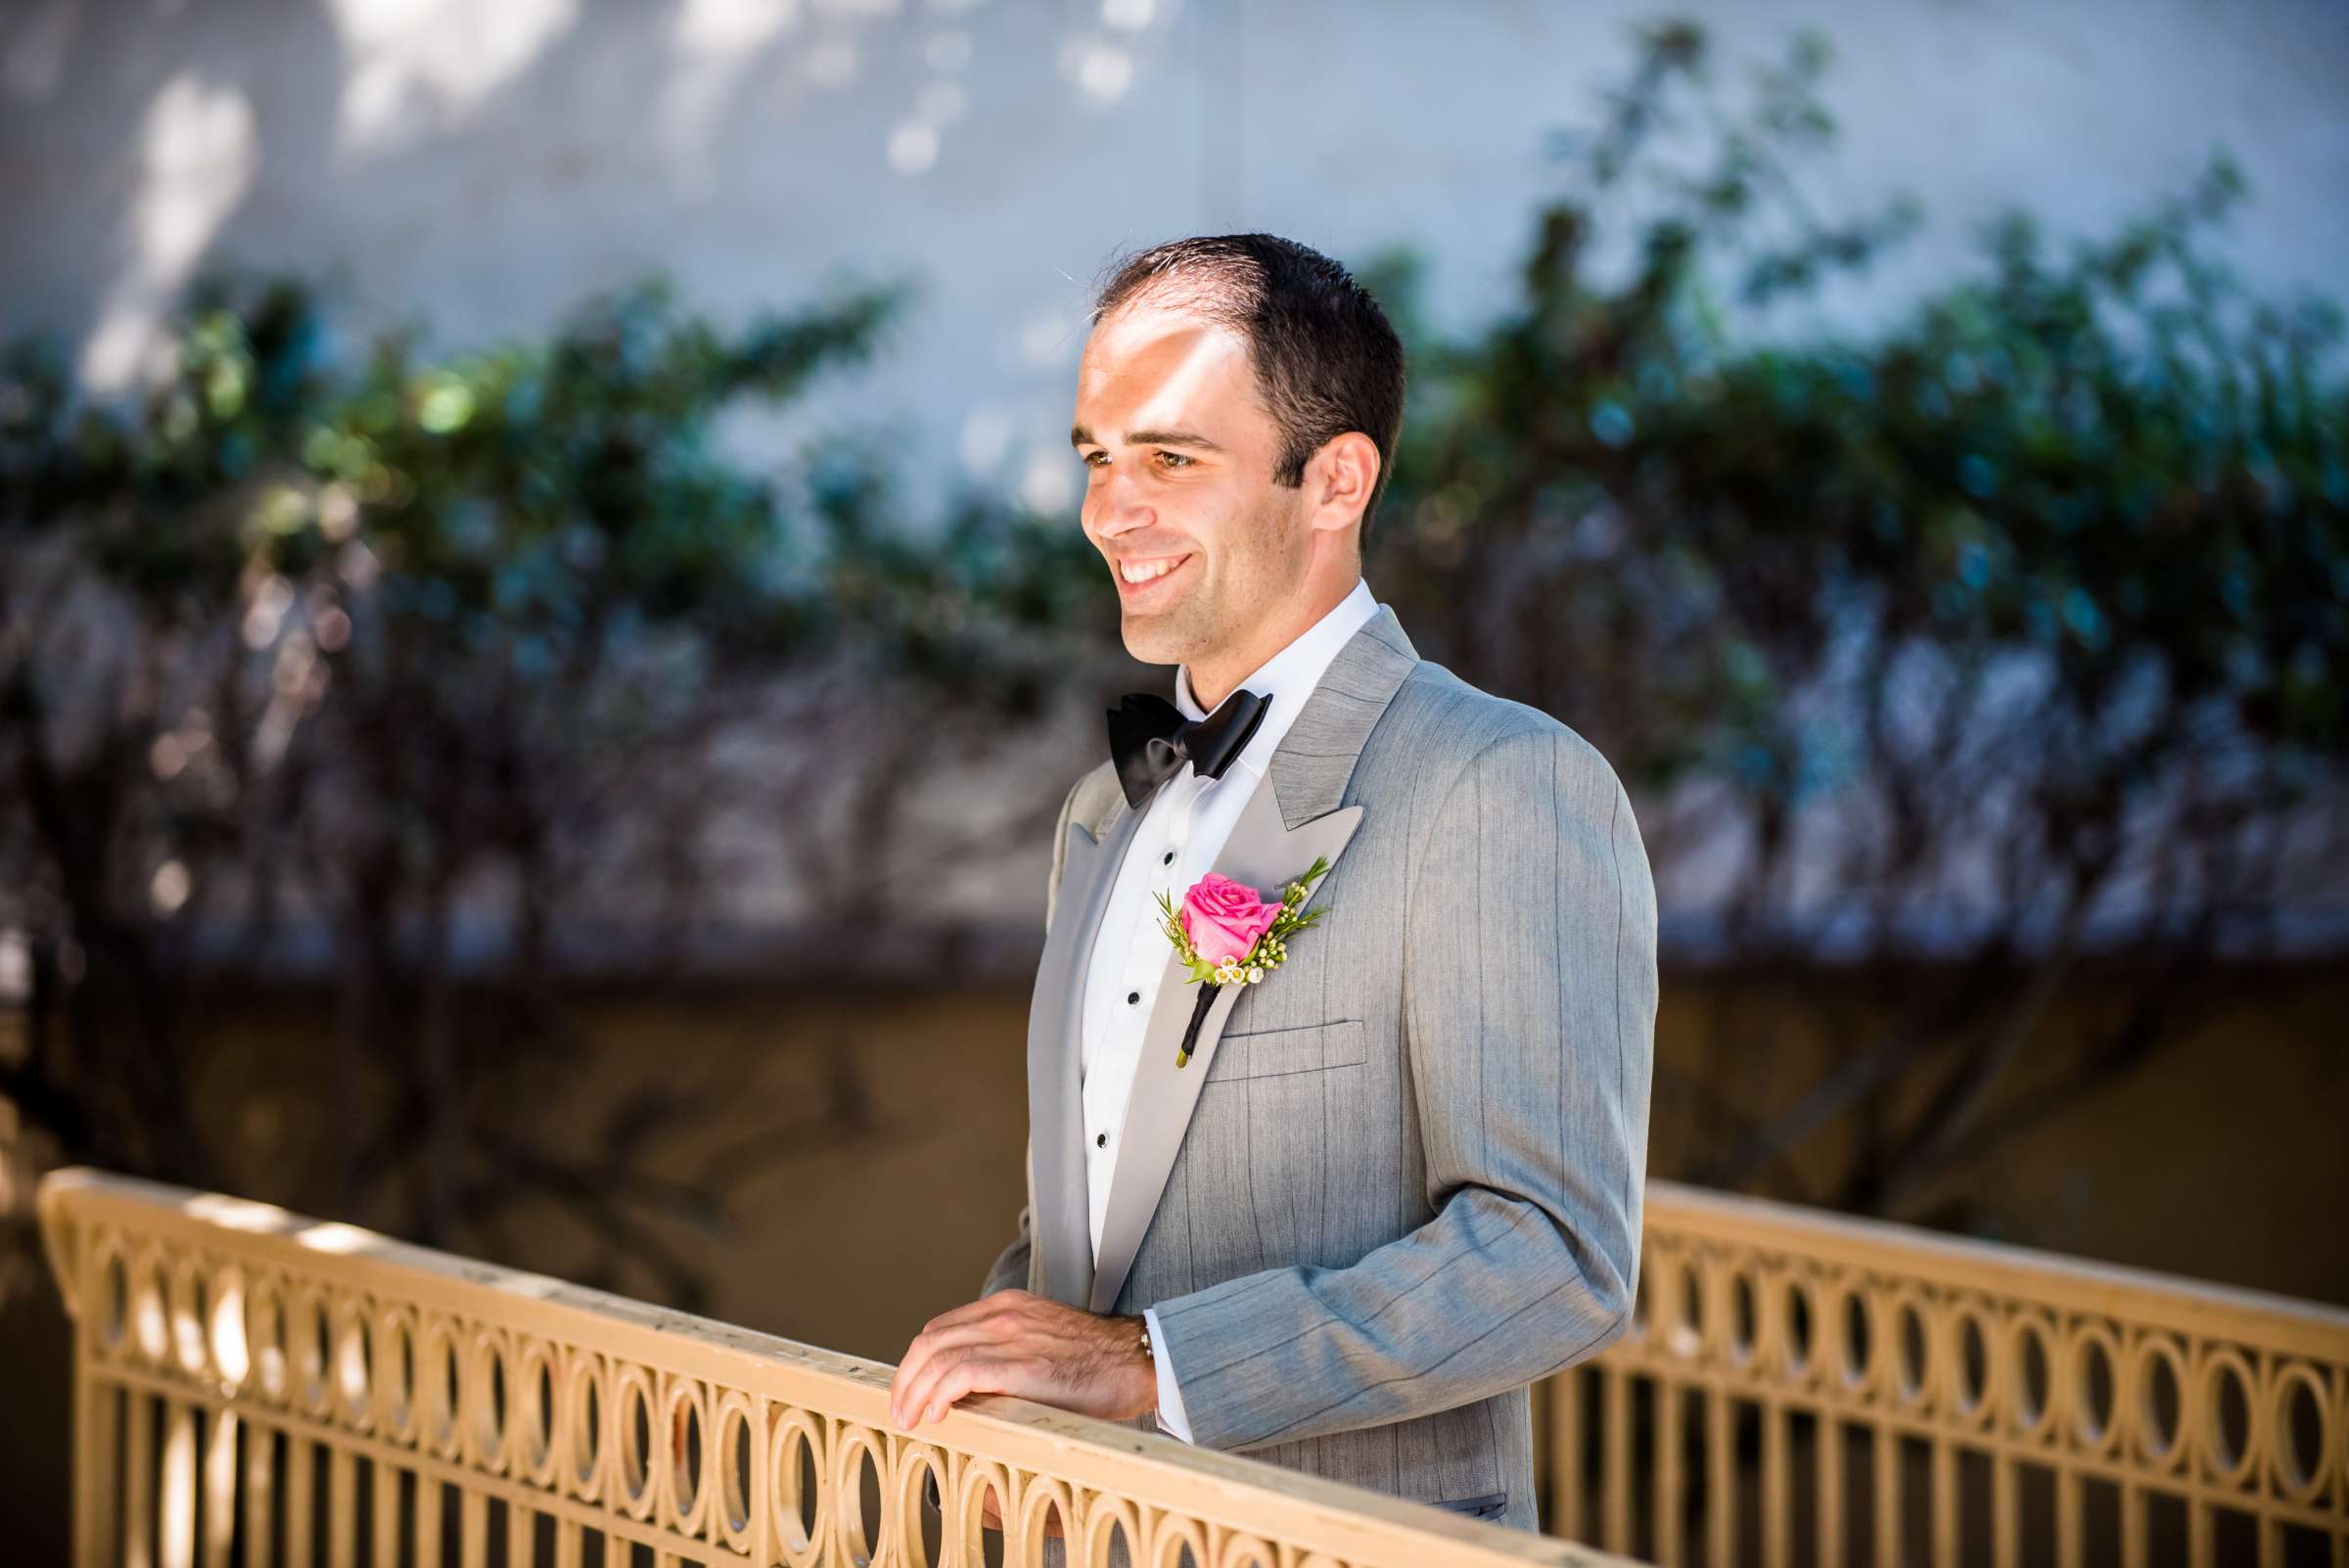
xmin=1090 ymin=235 xmax=1403 ymax=544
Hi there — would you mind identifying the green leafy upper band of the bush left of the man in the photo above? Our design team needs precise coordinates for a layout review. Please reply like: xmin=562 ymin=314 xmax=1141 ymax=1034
xmin=0 ymin=264 xmax=1084 ymax=717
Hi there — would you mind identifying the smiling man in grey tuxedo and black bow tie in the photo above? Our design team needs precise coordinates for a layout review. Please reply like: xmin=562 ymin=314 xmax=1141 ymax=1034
xmin=891 ymin=235 xmax=1656 ymax=1531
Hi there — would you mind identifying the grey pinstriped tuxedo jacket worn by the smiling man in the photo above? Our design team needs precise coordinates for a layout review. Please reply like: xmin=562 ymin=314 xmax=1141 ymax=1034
xmin=985 ymin=606 xmax=1656 ymax=1531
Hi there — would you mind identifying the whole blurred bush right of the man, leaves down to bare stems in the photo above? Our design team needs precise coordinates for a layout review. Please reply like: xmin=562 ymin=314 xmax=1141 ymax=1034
xmin=1364 ymin=23 xmax=2349 ymax=1222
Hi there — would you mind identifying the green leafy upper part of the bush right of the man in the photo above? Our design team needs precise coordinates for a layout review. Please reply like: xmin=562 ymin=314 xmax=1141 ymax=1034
xmin=1374 ymin=23 xmax=2349 ymax=905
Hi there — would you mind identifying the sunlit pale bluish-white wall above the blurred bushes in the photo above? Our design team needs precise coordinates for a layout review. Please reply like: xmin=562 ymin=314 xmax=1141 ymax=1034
xmin=0 ymin=0 xmax=2349 ymax=532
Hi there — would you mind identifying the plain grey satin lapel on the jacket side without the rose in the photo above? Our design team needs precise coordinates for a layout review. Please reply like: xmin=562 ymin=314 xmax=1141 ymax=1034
xmin=1029 ymin=798 xmax=1141 ymax=1308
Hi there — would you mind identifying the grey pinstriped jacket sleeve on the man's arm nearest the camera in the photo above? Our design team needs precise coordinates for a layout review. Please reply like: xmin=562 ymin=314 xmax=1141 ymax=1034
xmin=1136 ymin=723 xmax=1656 ymax=1451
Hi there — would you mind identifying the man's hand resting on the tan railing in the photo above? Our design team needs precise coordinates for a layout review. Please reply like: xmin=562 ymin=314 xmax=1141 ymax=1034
xmin=888 ymin=1289 xmax=1158 ymax=1432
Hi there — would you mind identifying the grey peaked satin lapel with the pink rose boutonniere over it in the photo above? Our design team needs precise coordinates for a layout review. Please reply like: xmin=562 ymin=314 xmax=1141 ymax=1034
xmin=1084 ymin=606 xmax=1419 ymax=1313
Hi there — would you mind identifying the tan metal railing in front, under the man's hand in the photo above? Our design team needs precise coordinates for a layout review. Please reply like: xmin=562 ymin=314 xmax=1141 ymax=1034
xmin=40 ymin=1167 xmax=1611 ymax=1568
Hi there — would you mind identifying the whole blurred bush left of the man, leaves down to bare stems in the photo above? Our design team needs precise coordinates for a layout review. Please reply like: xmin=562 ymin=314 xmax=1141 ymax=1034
xmin=0 ymin=277 xmax=1090 ymax=1301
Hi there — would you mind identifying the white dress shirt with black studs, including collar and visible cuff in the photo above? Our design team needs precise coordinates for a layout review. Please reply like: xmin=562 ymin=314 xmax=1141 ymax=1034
xmin=1079 ymin=577 xmax=1379 ymax=1444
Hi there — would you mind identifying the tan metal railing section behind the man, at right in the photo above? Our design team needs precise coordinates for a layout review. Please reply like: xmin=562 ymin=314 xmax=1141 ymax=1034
xmin=1541 ymin=1183 xmax=2349 ymax=1568
